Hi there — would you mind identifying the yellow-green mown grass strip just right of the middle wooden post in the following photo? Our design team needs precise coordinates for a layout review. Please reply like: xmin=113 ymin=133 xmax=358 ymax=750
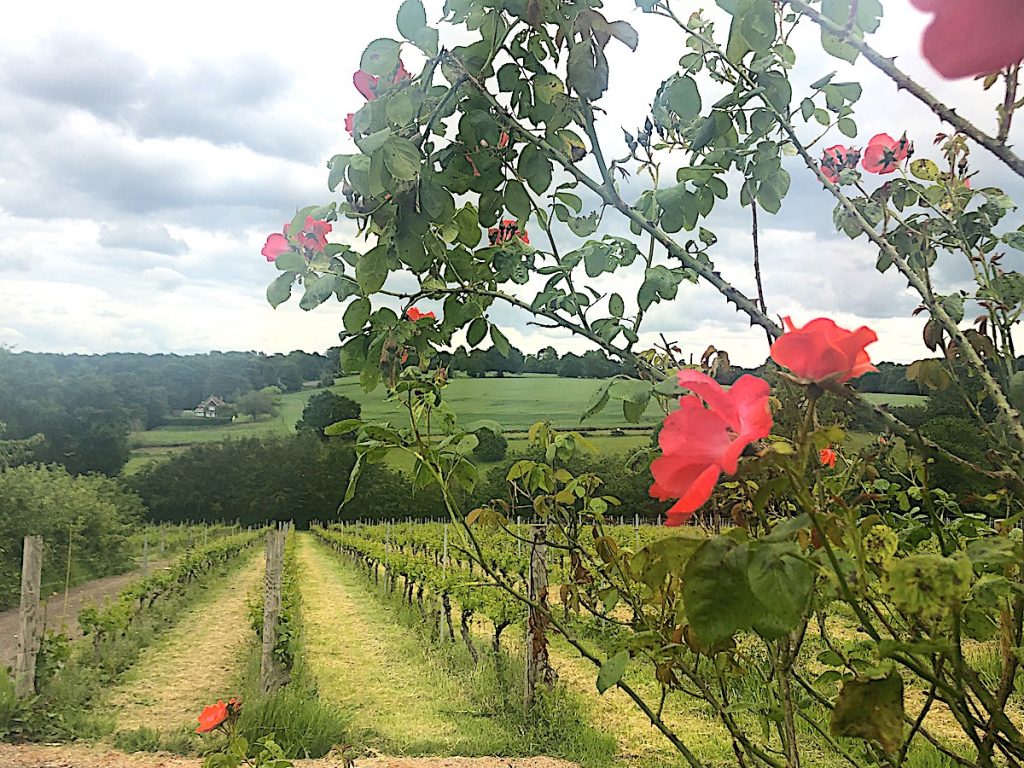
xmin=298 ymin=534 xmax=515 ymax=757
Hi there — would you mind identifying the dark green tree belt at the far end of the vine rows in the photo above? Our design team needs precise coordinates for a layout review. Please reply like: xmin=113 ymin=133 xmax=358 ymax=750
xmin=128 ymin=431 xmax=669 ymax=527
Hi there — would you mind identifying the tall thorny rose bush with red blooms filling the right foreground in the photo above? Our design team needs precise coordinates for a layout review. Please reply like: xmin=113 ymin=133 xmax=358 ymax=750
xmin=258 ymin=0 xmax=1024 ymax=768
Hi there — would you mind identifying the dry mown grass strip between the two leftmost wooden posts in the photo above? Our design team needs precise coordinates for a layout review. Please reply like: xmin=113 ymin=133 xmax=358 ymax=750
xmin=109 ymin=553 xmax=263 ymax=733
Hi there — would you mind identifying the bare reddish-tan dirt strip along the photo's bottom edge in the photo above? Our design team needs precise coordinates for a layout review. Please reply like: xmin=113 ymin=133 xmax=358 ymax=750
xmin=0 ymin=743 xmax=573 ymax=768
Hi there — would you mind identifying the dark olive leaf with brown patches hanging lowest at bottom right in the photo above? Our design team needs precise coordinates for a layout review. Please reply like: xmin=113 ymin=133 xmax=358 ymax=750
xmin=829 ymin=670 xmax=904 ymax=753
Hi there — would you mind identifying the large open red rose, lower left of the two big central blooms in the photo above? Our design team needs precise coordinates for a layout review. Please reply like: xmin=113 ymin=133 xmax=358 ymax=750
xmin=650 ymin=370 xmax=772 ymax=525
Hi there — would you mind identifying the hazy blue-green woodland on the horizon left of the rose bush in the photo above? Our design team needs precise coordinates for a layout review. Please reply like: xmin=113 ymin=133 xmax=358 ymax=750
xmin=0 ymin=348 xmax=338 ymax=475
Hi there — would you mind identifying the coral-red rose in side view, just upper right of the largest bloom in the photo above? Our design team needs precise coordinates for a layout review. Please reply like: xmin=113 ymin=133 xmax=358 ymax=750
xmin=771 ymin=317 xmax=879 ymax=383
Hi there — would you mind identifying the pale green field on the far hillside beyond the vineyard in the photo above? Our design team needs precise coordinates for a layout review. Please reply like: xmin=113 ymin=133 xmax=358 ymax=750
xmin=125 ymin=374 xmax=925 ymax=473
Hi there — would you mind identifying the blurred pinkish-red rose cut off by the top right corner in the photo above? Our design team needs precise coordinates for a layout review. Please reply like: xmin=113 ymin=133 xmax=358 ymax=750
xmin=910 ymin=0 xmax=1024 ymax=80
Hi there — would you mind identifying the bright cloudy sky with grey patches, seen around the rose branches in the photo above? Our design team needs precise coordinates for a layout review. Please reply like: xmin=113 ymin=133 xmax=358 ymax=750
xmin=0 ymin=0 xmax=1024 ymax=365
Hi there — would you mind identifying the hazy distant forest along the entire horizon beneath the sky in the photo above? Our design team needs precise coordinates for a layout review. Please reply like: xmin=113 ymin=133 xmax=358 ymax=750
xmin=0 ymin=347 xmax=918 ymax=475
